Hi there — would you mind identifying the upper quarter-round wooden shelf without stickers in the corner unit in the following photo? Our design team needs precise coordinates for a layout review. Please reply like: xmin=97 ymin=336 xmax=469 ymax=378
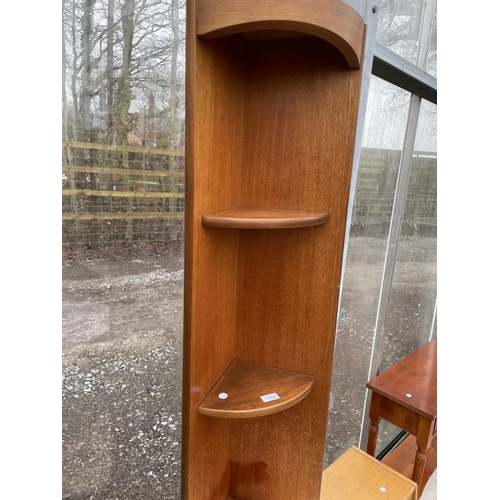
xmin=202 ymin=207 xmax=330 ymax=229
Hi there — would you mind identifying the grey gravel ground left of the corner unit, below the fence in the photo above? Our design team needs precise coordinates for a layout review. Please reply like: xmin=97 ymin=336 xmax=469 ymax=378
xmin=62 ymin=247 xmax=183 ymax=500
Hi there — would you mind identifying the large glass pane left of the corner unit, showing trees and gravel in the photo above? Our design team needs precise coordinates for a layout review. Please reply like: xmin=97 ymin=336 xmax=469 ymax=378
xmin=62 ymin=0 xmax=185 ymax=500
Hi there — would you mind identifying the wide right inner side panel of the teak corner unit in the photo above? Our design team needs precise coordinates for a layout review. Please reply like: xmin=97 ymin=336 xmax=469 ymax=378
xmin=230 ymin=38 xmax=361 ymax=500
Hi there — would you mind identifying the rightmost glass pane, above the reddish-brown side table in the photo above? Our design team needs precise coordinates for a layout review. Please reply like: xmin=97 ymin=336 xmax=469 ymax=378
xmin=377 ymin=101 xmax=437 ymax=450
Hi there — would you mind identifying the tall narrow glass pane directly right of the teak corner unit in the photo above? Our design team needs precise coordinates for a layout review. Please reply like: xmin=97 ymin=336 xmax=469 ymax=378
xmin=325 ymin=76 xmax=410 ymax=467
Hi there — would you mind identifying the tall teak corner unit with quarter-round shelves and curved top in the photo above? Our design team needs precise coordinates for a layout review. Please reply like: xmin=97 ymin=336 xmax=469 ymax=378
xmin=182 ymin=0 xmax=365 ymax=500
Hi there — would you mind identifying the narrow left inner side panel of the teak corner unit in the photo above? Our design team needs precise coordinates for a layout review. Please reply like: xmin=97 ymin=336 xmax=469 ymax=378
xmin=182 ymin=29 xmax=244 ymax=500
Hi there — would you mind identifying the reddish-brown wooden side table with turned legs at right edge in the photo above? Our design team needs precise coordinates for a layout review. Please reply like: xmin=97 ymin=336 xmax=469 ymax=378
xmin=366 ymin=339 xmax=437 ymax=491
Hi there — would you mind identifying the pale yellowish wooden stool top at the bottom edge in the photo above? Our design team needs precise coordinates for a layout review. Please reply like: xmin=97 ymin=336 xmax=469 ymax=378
xmin=320 ymin=446 xmax=418 ymax=500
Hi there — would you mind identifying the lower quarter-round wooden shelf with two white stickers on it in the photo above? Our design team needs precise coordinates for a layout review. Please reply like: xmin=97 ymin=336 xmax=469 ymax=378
xmin=198 ymin=359 xmax=315 ymax=418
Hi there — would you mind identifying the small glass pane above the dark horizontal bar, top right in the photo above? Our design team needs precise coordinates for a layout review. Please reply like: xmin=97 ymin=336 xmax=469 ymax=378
xmin=376 ymin=0 xmax=424 ymax=64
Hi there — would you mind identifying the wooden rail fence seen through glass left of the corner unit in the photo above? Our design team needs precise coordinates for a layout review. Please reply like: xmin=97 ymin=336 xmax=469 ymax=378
xmin=62 ymin=141 xmax=184 ymax=248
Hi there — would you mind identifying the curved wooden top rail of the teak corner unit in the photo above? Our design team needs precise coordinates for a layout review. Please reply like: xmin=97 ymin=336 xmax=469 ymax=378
xmin=196 ymin=0 xmax=364 ymax=69
